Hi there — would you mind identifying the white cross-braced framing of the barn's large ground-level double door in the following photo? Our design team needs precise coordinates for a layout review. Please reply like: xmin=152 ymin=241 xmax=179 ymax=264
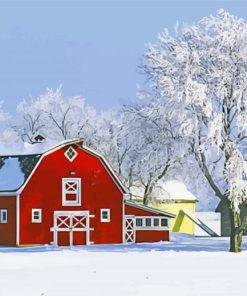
xmin=51 ymin=211 xmax=90 ymax=246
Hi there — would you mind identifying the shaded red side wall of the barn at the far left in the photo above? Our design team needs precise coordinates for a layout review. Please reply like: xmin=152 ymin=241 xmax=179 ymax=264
xmin=0 ymin=196 xmax=16 ymax=246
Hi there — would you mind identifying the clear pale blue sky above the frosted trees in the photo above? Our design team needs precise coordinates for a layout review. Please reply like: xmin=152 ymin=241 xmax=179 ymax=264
xmin=0 ymin=0 xmax=247 ymax=112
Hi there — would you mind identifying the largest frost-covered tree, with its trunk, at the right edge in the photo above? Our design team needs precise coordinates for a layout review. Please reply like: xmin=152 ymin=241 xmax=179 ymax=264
xmin=143 ymin=10 xmax=247 ymax=252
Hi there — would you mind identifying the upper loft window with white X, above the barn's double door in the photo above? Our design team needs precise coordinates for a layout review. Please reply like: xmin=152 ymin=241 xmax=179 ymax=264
xmin=62 ymin=178 xmax=81 ymax=206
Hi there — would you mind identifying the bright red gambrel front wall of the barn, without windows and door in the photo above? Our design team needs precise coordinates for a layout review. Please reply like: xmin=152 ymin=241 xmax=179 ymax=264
xmin=20 ymin=145 xmax=123 ymax=244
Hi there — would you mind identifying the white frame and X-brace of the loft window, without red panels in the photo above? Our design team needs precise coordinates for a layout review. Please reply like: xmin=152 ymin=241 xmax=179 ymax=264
xmin=62 ymin=178 xmax=81 ymax=206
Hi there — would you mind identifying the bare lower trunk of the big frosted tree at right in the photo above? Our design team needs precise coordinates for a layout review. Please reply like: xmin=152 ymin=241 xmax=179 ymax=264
xmin=229 ymin=209 xmax=244 ymax=253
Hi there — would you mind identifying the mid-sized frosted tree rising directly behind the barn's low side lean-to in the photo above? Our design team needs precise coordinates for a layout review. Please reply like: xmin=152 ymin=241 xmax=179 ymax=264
xmin=124 ymin=102 xmax=185 ymax=205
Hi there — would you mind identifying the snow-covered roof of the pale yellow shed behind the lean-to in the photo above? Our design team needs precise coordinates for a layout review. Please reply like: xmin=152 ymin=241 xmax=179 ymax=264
xmin=152 ymin=180 xmax=196 ymax=201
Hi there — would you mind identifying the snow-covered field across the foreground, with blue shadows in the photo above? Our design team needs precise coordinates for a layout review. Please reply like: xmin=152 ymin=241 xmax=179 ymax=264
xmin=0 ymin=235 xmax=247 ymax=296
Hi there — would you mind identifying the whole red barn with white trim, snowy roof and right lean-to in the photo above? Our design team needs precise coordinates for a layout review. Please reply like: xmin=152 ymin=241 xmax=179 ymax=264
xmin=0 ymin=139 xmax=174 ymax=246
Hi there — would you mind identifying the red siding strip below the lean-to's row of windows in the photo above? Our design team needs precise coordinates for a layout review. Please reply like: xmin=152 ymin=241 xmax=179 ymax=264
xmin=136 ymin=230 xmax=169 ymax=243
